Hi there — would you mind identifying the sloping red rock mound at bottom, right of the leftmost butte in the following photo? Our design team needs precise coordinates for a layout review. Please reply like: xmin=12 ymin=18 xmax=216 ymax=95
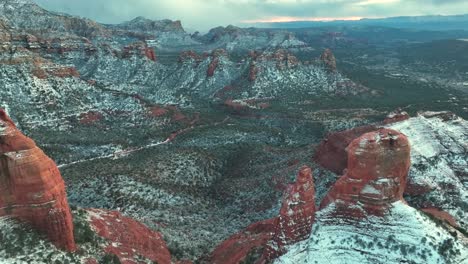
xmin=88 ymin=209 xmax=171 ymax=264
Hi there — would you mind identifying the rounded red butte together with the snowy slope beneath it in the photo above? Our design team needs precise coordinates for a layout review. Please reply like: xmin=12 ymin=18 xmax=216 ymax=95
xmin=274 ymin=128 xmax=467 ymax=264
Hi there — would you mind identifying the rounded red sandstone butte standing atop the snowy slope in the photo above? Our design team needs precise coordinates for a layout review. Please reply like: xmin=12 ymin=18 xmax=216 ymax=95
xmin=320 ymin=129 xmax=411 ymax=217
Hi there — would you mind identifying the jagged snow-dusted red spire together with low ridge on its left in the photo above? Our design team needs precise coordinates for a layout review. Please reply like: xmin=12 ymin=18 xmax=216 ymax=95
xmin=204 ymin=166 xmax=315 ymax=264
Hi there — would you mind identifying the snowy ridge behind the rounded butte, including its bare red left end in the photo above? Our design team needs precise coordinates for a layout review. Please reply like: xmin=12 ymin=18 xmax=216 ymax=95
xmin=314 ymin=112 xmax=468 ymax=228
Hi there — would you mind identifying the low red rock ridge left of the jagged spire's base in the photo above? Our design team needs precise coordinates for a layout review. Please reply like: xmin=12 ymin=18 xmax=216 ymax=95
xmin=202 ymin=218 xmax=276 ymax=264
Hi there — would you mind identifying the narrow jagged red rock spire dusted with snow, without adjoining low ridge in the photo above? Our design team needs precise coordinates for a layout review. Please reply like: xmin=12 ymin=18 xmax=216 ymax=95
xmin=264 ymin=166 xmax=315 ymax=260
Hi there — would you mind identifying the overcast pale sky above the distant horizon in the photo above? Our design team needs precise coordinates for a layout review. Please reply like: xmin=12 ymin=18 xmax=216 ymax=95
xmin=36 ymin=0 xmax=468 ymax=30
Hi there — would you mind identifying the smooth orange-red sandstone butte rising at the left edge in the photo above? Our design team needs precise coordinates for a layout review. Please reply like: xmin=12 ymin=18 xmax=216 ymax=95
xmin=0 ymin=109 xmax=76 ymax=251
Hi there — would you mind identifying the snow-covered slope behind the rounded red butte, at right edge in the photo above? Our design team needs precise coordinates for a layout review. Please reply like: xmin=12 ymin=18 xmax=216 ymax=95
xmin=389 ymin=112 xmax=468 ymax=229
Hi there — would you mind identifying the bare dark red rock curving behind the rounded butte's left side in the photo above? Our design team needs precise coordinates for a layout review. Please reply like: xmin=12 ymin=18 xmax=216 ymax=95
xmin=314 ymin=126 xmax=377 ymax=174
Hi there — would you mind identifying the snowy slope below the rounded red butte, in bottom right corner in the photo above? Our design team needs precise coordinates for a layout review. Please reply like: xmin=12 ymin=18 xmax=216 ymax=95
xmin=275 ymin=202 xmax=468 ymax=264
